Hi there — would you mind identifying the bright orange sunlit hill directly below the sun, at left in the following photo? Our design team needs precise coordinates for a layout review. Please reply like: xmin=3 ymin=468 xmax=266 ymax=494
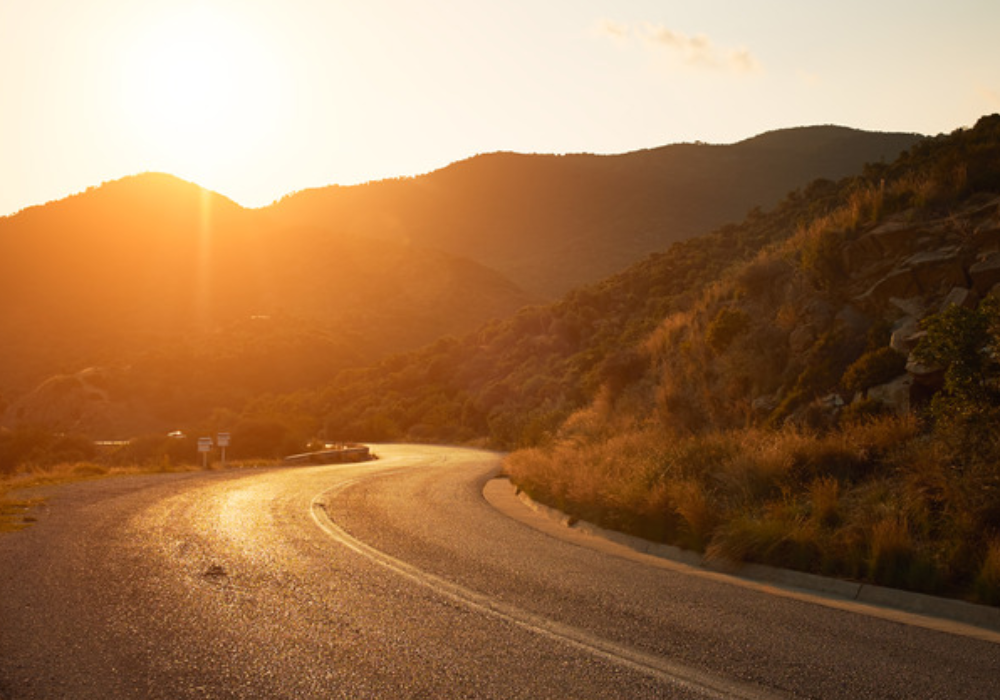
xmin=0 ymin=174 xmax=531 ymax=434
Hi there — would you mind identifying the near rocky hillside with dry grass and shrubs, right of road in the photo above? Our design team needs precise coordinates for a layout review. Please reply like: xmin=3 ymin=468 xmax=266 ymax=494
xmin=506 ymin=116 xmax=1000 ymax=604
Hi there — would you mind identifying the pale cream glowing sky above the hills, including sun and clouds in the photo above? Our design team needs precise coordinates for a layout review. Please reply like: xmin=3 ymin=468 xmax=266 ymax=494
xmin=0 ymin=0 xmax=1000 ymax=216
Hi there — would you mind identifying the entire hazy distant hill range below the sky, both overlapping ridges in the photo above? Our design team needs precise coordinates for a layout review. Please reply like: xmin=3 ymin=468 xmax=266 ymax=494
xmin=0 ymin=127 xmax=919 ymax=434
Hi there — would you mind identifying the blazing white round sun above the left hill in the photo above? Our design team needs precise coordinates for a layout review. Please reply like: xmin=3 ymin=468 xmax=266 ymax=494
xmin=123 ymin=4 xmax=282 ymax=182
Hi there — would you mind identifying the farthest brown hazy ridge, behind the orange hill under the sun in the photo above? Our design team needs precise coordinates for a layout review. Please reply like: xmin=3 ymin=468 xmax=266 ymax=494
xmin=267 ymin=126 xmax=922 ymax=298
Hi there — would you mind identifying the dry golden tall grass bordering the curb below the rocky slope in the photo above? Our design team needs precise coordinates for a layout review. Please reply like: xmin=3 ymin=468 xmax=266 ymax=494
xmin=505 ymin=416 xmax=1000 ymax=604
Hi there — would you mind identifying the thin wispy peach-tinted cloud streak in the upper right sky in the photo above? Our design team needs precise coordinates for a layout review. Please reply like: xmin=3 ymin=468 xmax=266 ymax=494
xmin=598 ymin=19 xmax=762 ymax=75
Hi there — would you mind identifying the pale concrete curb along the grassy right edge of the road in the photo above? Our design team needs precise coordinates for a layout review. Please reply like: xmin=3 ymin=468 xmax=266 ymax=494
xmin=500 ymin=485 xmax=1000 ymax=632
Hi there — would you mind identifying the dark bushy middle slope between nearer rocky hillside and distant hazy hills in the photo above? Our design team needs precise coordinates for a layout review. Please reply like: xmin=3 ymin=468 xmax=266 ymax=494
xmin=240 ymin=172 xmax=851 ymax=448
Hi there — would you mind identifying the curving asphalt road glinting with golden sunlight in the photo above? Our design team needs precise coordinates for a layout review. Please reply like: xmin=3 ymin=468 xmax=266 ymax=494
xmin=0 ymin=446 xmax=1000 ymax=700
